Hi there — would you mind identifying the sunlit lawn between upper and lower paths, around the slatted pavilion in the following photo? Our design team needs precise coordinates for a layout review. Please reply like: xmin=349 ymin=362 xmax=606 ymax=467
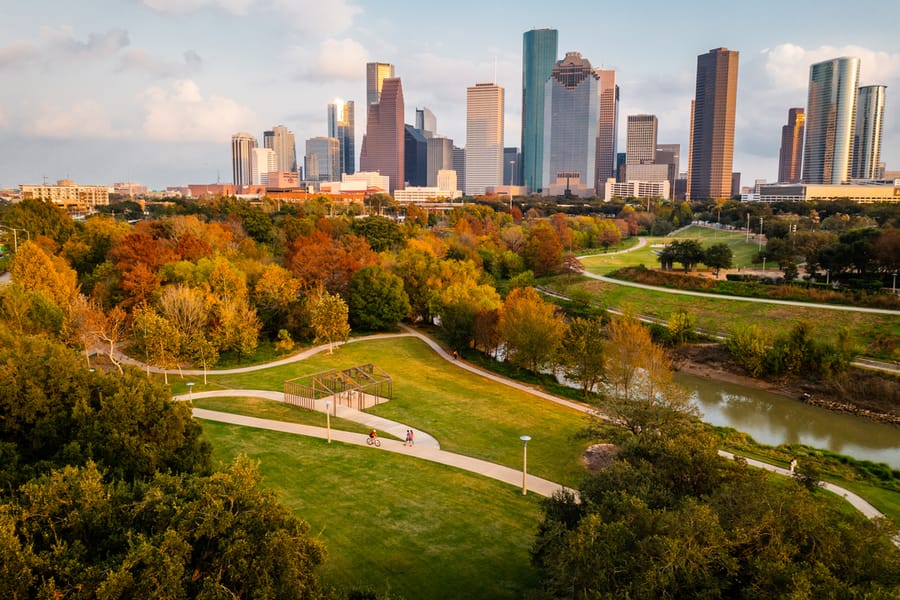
xmin=170 ymin=337 xmax=587 ymax=487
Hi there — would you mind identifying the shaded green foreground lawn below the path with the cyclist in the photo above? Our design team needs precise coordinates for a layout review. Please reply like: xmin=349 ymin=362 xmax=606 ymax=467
xmin=203 ymin=422 xmax=540 ymax=599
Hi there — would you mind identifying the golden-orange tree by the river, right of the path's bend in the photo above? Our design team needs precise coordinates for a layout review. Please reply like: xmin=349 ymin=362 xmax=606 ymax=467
xmin=499 ymin=288 xmax=565 ymax=373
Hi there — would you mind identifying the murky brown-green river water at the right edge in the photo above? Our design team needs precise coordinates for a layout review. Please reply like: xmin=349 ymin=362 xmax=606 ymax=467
xmin=675 ymin=372 xmax=900 ymax=469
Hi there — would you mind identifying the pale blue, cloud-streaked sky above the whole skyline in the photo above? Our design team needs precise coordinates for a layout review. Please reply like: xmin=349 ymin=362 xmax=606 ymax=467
xmin=0 ymin=0 xmax=900 ymax=189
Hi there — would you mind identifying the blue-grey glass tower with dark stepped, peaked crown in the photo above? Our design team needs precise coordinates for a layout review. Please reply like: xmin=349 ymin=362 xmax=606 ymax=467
xmin=541 ymin=52 xmax=613 ymax=190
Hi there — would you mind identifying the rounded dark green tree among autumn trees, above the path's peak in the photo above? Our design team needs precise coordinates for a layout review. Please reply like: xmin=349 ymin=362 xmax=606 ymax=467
xmin=347 ymin=265 xmax=409 ymax=331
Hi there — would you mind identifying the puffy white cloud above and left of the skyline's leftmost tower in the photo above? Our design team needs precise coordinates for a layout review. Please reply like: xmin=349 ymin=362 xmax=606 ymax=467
xmin=143 ymin=79 xmax=258 ymax=142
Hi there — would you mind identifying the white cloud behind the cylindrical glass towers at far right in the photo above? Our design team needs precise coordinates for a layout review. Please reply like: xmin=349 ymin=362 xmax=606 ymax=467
xmin=762 ymin=44 xmax=900 ymax=90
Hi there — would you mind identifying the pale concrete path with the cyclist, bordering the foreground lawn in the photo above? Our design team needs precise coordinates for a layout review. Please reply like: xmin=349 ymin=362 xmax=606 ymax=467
xmin=193 ymin=408 xmax=578 ymax=497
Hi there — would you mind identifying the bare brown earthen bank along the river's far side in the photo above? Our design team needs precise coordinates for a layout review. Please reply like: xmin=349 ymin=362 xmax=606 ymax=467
xmin=672 ymin=344 xmax=900 ymax=426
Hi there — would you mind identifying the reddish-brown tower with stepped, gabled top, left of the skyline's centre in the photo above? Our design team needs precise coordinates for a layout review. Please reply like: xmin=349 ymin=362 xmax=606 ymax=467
xmin=359 ymin=77 xmax=405 ymax=194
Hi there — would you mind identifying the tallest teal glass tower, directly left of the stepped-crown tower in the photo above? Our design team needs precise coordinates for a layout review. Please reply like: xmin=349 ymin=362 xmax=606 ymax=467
xmin=521 ymin=29 xmax=559 ymax=192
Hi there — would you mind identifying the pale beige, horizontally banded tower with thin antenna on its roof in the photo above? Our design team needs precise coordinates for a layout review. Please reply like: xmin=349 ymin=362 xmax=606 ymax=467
xmin=466 ymin=83 xmax=503 ymax=196
